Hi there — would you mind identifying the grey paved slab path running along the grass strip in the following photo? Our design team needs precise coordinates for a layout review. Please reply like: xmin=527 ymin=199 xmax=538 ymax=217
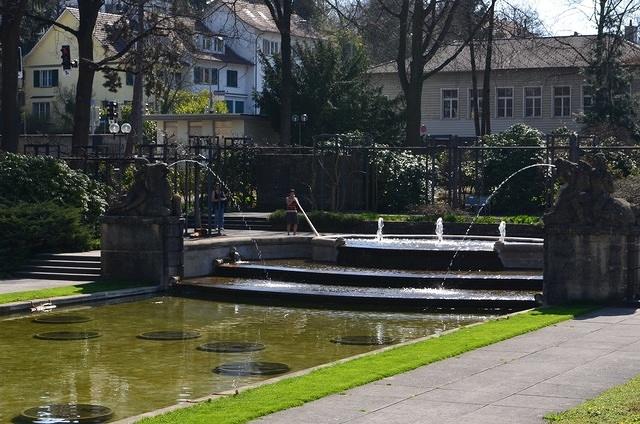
xmin=255 ymin=308 xmax=640 ymax=424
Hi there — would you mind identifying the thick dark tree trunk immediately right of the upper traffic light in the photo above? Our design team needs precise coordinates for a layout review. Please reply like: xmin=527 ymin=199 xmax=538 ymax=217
xmin=71 ymin=0 xmax=102 ymax=151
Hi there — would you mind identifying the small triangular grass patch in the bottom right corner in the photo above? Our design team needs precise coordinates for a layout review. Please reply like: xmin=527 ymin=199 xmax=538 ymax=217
xmin=545 ymin=376 xmax=640 ymax=424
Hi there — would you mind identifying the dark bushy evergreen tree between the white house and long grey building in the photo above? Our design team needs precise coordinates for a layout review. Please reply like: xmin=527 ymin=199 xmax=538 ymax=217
xmin=257 ymin=32 xmax=401 ymax=144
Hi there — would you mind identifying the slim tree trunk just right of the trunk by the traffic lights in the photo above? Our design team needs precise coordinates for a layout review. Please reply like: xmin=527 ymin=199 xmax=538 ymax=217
xmin=124 ymin=0 xmax=144 ymax=157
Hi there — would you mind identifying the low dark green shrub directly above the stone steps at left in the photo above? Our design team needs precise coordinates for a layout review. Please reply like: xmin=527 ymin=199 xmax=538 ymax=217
xmin=0 ymin=201 xmax=92 ymax=272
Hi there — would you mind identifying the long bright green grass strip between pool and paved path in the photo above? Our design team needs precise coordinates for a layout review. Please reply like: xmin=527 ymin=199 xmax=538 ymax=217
xmin=141 ymin=306 xmax=593 ymax=424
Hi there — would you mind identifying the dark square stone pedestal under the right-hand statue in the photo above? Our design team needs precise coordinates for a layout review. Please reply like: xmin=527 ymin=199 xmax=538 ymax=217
xmin=543 ymin=224 xmax=635 ymax=305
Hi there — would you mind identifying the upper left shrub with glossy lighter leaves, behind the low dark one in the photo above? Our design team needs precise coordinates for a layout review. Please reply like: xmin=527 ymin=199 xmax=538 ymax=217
xmin=0 ymin=153 xmax=106 ymax=228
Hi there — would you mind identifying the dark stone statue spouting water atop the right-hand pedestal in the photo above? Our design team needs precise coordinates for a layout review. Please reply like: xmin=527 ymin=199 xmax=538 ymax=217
xmin=544 ymin=153 xmax=635 ymax=226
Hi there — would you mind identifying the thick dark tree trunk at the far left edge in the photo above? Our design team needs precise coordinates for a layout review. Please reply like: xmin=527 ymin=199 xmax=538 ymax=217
xmin=0 ymin=0 xmax=26 ymax=153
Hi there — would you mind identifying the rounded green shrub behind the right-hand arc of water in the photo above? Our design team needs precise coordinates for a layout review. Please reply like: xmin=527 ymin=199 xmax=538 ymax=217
xmin=483 ymin=124 xmax=545 ymax=214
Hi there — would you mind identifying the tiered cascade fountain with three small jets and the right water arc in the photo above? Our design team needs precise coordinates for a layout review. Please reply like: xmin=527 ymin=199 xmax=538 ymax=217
xmin=184 ymin=164 xmax=549 ymax=310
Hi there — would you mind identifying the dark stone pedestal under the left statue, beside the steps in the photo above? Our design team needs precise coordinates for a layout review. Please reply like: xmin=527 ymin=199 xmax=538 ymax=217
xmin=101 ymin=216 xmax=184 ymax=288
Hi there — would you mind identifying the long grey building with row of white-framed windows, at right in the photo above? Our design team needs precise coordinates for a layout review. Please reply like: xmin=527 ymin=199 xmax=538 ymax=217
xmin=371 ymin=35 xmax=640 ymax=137
